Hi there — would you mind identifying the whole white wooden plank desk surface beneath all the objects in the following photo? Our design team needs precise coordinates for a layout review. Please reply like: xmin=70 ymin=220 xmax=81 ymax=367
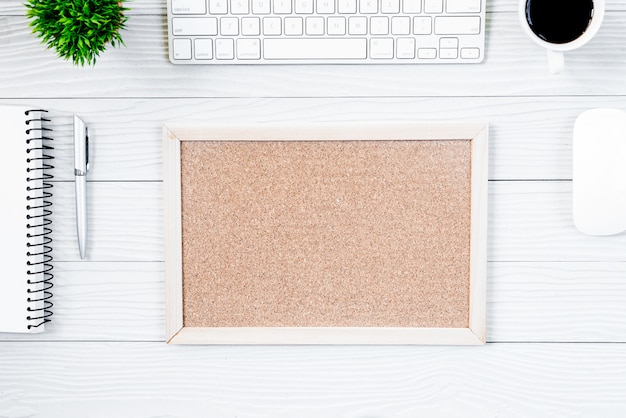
xmin=0 ymin=0 xmax=626 ymax=418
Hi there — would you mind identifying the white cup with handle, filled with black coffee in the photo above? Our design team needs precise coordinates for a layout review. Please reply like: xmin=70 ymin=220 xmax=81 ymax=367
xmin=519 ymin=0 xmax=605 ymax=74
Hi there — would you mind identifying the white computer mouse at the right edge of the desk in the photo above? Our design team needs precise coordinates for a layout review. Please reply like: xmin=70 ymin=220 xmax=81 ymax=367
xmin=572 ymin=109 xmax=626 ymax=235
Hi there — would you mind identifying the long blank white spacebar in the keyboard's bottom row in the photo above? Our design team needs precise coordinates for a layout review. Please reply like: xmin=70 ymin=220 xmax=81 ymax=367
xmin=263 ymin=38 xmax=367 ymax=60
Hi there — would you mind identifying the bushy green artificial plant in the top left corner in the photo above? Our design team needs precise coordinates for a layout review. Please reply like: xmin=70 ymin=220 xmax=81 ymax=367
xmin=24 ymin=0 xmax=128 ymax=66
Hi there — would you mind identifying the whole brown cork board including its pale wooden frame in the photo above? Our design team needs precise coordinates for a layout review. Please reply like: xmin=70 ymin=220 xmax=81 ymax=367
xmin=164 ymin=125 xmax=487 ymax=344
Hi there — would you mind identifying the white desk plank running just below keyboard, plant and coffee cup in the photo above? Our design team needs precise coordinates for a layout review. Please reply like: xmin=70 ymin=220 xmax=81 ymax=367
xmin=0 ymin=12 xmax=626 ymax=98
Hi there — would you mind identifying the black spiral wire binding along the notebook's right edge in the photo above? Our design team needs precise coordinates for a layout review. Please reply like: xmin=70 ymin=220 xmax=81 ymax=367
xmin=25 ymin=109 xmax=54 ymax=329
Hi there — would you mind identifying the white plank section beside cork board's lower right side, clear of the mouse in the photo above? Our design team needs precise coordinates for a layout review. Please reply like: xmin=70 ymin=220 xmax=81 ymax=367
xmin=487 ymin=262 xmax=626 ymax=343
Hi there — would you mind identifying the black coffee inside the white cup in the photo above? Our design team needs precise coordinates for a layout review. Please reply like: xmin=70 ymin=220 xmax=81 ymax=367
xmin=526 ymin=0 xmax=593 ymax=44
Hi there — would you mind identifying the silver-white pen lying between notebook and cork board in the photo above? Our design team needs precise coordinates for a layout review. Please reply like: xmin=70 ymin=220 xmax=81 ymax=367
xmin=74 ymin=115 xmax=89 ymax=260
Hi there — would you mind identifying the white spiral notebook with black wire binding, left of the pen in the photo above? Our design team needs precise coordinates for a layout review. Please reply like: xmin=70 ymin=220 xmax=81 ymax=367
xmin=0 ymin=105 xmax=53 ymax=332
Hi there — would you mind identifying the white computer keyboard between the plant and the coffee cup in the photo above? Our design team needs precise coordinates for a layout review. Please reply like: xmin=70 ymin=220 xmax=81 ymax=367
xmin=167 ymin=0 xmax=486 ymax=64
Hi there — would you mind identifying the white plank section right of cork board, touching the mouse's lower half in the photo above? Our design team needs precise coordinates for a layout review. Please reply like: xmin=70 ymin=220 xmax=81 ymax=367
xmin=487 ymin=182 xmax=626 ymax=262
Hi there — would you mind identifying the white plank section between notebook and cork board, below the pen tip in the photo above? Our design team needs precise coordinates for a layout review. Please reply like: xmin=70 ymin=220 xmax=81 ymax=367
xmin=0 ymin=262 xmax=165 ymax=342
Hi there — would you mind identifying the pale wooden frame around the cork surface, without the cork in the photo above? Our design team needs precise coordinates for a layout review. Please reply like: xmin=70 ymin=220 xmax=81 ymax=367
xmin=163 ymin=123 xmax=488 ymax=345
